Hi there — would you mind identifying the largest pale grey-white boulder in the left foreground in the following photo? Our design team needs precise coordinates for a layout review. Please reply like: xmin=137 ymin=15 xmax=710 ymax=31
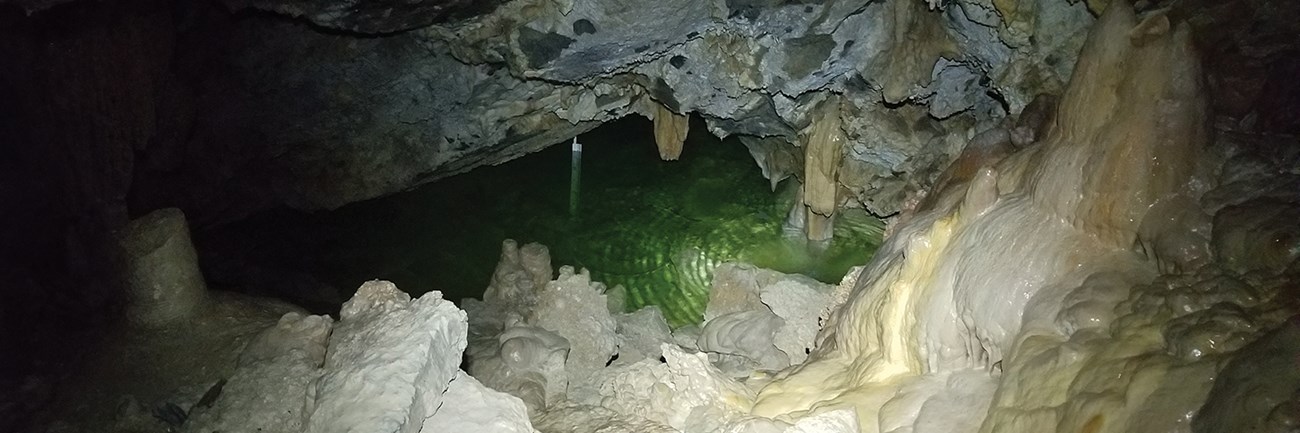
xmin=307 ymin=281 xmax=467 ymax=433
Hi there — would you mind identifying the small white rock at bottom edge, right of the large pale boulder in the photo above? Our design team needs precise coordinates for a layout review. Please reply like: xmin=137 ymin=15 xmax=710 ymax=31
xmin=420 ymin=372 xmax=537 ymax=433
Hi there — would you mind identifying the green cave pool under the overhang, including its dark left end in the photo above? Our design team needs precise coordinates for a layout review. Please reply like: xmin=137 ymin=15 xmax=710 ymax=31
xmin=196 ymin=116 xmax=884 ymax=326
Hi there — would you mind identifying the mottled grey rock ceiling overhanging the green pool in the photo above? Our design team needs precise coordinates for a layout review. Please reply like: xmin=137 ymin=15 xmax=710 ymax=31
xmin=119 ymin=0 xmax=1093 ymax=224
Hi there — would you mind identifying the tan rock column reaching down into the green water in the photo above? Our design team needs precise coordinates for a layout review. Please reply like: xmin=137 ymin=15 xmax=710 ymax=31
xmin=801 ymin=96 xmax=848 ymax=241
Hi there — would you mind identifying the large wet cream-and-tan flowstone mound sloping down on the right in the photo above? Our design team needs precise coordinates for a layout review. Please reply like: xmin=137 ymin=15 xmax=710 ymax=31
xmin=738 ymin=3 xmax=1295 ymax=432
